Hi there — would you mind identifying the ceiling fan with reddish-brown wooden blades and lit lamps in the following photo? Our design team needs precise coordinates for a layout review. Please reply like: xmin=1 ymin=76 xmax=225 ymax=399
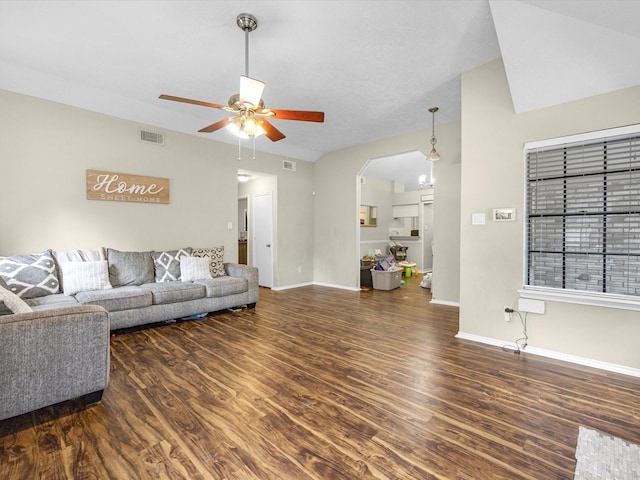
xmin=160 ymin=13 xmax=324 ymax=142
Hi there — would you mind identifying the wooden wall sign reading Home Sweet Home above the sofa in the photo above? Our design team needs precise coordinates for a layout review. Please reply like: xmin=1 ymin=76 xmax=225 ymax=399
xmin=87 ymin=170 xmax=169 ymax=203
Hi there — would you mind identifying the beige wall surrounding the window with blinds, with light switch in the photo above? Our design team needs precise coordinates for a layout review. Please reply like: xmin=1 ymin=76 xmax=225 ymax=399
xmin=460 ymin=61 xmax=640 ymax=368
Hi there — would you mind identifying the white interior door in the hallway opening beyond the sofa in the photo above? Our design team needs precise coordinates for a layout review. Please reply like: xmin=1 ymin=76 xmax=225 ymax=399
xmin=251 ymin=193 xmax=273 ymax=288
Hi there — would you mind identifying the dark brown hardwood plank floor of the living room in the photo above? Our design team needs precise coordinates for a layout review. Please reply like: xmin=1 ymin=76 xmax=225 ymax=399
xmin=0 ymin=277 xmax=640 ymax=480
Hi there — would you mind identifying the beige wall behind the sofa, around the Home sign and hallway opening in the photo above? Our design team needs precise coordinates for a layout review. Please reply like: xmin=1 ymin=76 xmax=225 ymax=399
xmin=0 ymin=91 xmax=313 ymax=283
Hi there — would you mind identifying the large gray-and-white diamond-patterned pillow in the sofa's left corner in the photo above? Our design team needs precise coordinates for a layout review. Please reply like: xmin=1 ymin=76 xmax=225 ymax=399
xmin=0 ymin=250 xmax=60 ymax=298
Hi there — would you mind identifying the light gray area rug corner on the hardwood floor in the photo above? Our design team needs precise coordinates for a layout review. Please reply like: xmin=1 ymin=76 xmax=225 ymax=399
xmin=574 ymin=427 xmax=640 ymax=480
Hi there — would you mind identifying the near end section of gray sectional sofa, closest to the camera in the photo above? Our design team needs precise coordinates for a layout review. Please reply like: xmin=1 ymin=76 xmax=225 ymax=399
xmin=0 ymin=305 xmax=110 ymax=420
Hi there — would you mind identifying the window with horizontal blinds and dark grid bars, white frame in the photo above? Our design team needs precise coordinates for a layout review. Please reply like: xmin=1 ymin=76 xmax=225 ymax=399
xmin=521 ymin=126 xmax=640 ymax=309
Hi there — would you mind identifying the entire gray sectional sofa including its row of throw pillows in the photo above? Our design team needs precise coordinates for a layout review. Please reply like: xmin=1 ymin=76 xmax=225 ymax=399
xmin=0 ymin=247 xmax=259 ymax=420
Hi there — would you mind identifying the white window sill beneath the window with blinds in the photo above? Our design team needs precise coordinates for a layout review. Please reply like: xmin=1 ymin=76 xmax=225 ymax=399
xmin=518 ymin=287 xmax=640 ymax=311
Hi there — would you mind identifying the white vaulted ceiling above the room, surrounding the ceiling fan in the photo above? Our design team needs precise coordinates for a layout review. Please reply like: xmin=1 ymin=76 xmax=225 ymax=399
xmin=0 ymin=0 xmax=640 ymax=161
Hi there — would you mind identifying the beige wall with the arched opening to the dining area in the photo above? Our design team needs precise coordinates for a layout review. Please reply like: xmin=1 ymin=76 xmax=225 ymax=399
xmin=314 ymin=123 xmax=460 ymax=303
